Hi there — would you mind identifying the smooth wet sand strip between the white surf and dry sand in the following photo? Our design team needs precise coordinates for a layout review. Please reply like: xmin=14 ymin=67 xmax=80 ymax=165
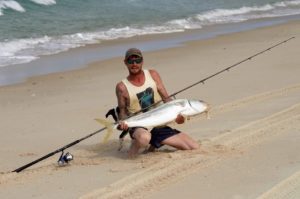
xmin=0 ymin=15 xmax=300 ymax=87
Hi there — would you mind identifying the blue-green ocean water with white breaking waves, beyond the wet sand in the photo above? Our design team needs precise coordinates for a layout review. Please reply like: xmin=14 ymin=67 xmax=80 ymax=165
xmin=0 ymin=0 xmax=300 ymax=83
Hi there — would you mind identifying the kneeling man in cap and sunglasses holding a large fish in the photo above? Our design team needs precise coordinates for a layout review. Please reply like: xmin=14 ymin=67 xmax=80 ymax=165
xmin=116 ymin=48 xmax=199 ymax=157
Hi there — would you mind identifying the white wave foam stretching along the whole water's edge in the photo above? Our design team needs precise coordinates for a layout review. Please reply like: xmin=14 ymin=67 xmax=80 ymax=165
xmin=0 ymin=0 xmax=300 ymax=66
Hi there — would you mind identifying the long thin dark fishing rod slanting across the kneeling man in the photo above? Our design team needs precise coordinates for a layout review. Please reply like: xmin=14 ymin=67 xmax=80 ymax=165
xmin=12 ymin=37 xmax=295 ymax=173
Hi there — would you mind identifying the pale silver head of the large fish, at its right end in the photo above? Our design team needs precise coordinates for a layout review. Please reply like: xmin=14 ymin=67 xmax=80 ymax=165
xmin=181 ymin=100 xmax=209 ymax=116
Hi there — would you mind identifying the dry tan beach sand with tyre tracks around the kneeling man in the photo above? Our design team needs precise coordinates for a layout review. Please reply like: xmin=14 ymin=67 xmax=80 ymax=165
xmin=0 ymin=21 xmax=300 ymax=199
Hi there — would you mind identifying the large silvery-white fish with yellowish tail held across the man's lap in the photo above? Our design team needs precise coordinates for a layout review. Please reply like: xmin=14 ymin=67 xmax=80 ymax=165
xmin=96 ymin=99 xmax=209 ymax=129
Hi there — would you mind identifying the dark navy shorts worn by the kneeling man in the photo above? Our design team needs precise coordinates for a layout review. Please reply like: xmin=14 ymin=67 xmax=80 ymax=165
xmin=129 ymin=126 xmax=180 ymax=148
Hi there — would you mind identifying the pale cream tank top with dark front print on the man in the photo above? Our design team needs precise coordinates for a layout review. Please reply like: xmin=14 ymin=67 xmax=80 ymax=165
xmin=122 ymin=70 xmax=161 ymax=115
